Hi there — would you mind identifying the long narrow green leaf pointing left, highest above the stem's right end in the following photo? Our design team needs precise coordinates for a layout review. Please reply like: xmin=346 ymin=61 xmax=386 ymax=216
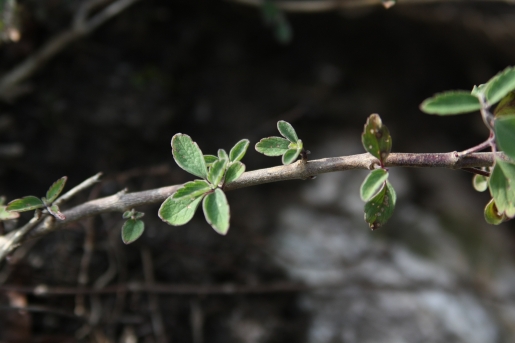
xmin=420 ymin=91 xmax=481 ymax=115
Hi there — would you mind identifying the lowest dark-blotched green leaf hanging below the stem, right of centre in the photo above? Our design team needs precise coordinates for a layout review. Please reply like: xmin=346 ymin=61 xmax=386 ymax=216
xmin=365 ymin=181 xmax=397 ymax=230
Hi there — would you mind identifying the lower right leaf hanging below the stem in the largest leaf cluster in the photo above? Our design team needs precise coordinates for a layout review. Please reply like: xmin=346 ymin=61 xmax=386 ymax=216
xmin=202 ymin=188 xmax=230 ymax=235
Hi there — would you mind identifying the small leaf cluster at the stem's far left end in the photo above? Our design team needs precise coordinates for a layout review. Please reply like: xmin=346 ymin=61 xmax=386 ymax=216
xmin=5 ymin=176 xmax=68 ymax=220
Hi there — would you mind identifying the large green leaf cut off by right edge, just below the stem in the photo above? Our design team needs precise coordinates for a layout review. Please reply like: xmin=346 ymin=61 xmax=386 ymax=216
xmin=488 ymin=158 xmax=515 ymax=218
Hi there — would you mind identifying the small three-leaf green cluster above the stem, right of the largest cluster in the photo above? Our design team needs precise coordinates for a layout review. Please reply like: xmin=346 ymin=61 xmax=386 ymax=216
xmin=256 ymin=120 xmax=304 ymax=165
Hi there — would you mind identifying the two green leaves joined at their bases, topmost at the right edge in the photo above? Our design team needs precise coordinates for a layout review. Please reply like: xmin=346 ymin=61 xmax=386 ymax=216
xmin=420 ymin=67 xmax=515 ymax=115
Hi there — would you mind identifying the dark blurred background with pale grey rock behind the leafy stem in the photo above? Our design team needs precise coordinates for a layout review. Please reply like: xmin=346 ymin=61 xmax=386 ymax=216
xmin=0 ymin=0 xmax=515 ymax=343
